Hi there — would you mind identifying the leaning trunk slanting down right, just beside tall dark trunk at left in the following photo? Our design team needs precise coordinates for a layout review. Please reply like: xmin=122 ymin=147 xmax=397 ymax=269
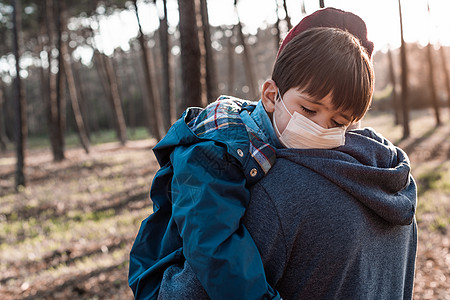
xmin=59 ymin=0 xmax=90 ymax=153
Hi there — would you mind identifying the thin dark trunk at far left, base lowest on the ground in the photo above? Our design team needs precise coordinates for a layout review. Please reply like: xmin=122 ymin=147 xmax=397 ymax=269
xmin=12 ymin=0 xmax=27 ymax=190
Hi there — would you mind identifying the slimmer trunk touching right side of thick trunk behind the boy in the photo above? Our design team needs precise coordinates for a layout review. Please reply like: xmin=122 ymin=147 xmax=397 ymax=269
xmin=200 ymin=0 xmax=219 ymax=102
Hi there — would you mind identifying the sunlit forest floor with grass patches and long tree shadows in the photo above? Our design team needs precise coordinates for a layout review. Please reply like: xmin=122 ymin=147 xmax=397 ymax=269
xmin=0 ymin=111 xmax=450 ymax=300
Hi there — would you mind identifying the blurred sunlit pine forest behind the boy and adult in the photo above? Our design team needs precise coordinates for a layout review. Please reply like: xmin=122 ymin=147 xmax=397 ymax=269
xmin=0 ymin=0 xmax=450 ymax=299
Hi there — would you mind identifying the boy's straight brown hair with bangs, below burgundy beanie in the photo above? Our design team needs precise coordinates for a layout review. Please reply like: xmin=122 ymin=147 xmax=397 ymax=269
xmin=272 ymin=27 xmax=374 ymax=122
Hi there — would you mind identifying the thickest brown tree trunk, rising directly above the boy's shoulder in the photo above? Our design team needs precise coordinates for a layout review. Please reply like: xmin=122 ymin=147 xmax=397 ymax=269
xmin=178 ymin=0 xmax=202 ymax=109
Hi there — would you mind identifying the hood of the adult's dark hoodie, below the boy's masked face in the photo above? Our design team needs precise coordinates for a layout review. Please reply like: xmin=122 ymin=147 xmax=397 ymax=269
xmin=277 ymin=128 xmax=417 ymax=225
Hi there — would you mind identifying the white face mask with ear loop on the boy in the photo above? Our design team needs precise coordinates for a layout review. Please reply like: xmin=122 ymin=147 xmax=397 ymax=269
xmin=273 ymin=90 xmax=345 ymax=149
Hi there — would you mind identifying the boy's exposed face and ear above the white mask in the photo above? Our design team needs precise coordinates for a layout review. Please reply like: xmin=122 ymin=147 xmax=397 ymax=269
xmin=262 ymin=80 xmax=352 ymax=132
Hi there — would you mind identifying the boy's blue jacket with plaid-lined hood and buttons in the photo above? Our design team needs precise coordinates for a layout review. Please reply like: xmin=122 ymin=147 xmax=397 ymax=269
xmin=129 ymin=97 xmax=279 ymax=299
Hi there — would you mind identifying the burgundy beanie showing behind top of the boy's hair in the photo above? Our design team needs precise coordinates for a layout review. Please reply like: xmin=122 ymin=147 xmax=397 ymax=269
xmin=277 ymin=7 xmax=373 ymax=58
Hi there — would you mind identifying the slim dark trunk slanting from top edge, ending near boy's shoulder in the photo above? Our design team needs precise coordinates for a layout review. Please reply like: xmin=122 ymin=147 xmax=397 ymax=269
xmin=133 ymin=0 xmax=165 ymax=140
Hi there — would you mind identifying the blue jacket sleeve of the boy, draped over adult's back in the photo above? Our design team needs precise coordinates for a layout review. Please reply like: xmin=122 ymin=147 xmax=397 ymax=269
xmin=171 ymin=141 xmax=280 ymax=299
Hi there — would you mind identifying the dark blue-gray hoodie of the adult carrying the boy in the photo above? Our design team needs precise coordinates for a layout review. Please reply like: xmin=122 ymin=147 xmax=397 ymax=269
xmin=160 ymin=128 xmax=417 ymax=299
